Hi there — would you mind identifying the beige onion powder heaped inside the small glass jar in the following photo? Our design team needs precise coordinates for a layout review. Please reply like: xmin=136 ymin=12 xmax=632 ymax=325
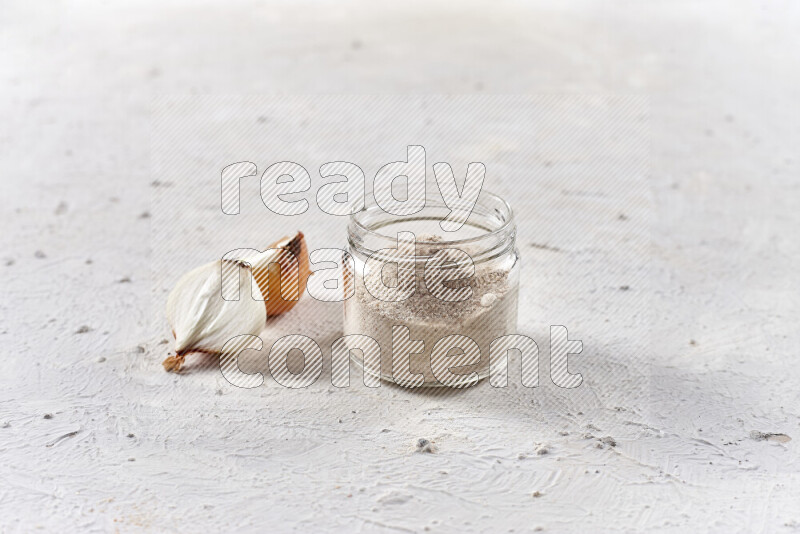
xmin=344 ymin=235 xmax=518 ymax=386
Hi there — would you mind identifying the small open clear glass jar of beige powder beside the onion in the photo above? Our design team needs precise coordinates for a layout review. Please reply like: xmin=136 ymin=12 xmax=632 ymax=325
xmin=344 ymin=193 xmax=520 ymax=387
